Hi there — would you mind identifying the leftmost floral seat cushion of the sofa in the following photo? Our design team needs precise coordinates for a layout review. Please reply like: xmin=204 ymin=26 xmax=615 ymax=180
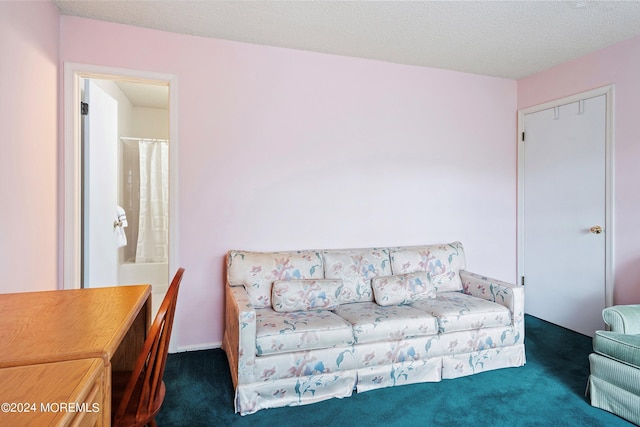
xmin=256 ymin=308 xmax=353 ymax=356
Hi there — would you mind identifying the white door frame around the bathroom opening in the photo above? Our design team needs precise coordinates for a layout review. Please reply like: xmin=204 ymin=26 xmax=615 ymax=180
xmin=62 ymin=62 xmax=179 ymax=289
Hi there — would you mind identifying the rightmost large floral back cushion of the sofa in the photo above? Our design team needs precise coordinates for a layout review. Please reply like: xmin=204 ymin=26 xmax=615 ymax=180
xmin=391 ymin=242 xmax=466 ymax=292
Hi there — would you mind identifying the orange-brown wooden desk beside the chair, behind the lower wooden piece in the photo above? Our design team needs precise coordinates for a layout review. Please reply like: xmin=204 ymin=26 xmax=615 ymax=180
xmin=0 ymin=285 xmax=151 ymax=425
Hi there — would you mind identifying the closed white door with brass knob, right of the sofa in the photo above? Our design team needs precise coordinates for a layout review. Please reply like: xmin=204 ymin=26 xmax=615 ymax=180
xmin=521 ymin=95 xmax=607 ymax=336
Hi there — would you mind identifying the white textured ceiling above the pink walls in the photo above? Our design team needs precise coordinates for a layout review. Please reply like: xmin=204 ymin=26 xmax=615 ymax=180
xmin=53 ymin=0 xmax=640 ymax=79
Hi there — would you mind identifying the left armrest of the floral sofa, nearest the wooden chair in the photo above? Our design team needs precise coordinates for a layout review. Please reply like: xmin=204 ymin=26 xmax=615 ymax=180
xmin=222 ymin=284 xmax=256 ymax=388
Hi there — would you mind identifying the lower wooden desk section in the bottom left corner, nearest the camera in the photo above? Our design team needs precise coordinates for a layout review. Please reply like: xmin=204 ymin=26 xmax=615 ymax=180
xmin=0 ymin=359 xmax=104 ymax=427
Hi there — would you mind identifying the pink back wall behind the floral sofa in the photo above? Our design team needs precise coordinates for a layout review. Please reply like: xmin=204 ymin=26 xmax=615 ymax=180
xmin=60 ymin=16 xmax=516 ymax=348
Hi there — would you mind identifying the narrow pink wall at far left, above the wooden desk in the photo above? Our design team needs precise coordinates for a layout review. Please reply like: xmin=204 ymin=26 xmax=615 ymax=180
xmin=0 ymin=1 xmax=59 ymax=292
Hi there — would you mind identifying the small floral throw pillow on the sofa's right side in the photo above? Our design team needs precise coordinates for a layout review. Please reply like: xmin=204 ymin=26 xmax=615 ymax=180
xmin=371 ymin=271 xmax=436 ymax=306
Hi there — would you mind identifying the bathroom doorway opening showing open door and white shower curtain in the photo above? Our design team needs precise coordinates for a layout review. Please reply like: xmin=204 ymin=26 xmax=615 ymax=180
xmin=80 ymin=77 xmax=170 ymax=318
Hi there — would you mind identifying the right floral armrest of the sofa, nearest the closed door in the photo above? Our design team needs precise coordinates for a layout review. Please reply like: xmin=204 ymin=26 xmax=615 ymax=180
xmin=460 ymin=270 xmax=524 ymax=337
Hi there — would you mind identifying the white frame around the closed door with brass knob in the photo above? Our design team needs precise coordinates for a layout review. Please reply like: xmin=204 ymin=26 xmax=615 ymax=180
xmin=516 ymin=84 xmax=615 ymax=311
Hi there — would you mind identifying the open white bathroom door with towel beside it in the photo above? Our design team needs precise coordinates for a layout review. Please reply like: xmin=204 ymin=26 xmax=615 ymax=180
xmin=82 ymin=79 xmax=118 ymax=288
